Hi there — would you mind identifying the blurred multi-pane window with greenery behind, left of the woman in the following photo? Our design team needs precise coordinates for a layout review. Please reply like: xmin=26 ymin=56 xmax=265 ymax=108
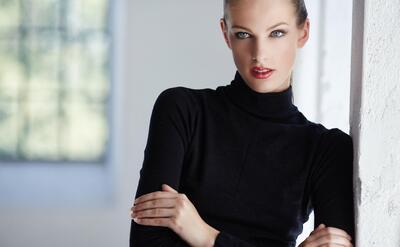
xmin=0 ymin=0 xmax=111 ymax=162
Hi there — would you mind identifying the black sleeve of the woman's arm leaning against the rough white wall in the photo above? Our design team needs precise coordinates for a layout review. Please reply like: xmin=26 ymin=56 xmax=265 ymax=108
xmin=311 ymin=128 xmax=355 ymax=244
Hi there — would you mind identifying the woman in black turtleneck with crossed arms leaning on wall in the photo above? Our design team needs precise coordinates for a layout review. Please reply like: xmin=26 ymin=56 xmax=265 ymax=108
xmin=130 ymin=0 xmax=354 ymax=247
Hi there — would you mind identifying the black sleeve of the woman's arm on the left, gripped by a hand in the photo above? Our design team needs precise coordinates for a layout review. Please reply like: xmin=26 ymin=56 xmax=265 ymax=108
xmin=130 ymin=88 xmax=194 ymax=247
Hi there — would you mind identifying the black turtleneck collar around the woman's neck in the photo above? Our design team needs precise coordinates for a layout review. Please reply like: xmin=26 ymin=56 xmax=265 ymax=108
xmin=226 ymin=71 xmax=298 ymax=119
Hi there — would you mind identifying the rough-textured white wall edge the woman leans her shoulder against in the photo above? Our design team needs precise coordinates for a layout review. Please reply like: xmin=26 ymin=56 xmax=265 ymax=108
xmin=350 ymin=0 xmax=400 ymax=247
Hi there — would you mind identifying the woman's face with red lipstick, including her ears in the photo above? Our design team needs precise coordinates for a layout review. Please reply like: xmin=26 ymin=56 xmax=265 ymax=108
xmin=220 ymin=0 xmax=309 ymax=92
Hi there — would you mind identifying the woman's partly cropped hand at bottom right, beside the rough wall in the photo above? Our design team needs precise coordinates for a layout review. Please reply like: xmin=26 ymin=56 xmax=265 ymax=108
xmin=298 ymin=224 xmax=353 ymax=247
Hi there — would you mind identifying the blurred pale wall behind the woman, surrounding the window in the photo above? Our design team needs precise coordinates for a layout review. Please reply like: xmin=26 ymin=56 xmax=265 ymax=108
xmin=0 ymin=0 xmax=351 ymax=247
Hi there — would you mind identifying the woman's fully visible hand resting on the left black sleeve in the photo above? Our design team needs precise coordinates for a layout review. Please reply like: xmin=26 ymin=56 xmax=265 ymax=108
xmin=131 ymin=184 xmax=219 ymax=247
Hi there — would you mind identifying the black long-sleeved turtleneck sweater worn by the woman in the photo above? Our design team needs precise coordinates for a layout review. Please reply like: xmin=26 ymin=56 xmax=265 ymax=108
xmin=130 ymin=71 xmax=354 ymax=247
